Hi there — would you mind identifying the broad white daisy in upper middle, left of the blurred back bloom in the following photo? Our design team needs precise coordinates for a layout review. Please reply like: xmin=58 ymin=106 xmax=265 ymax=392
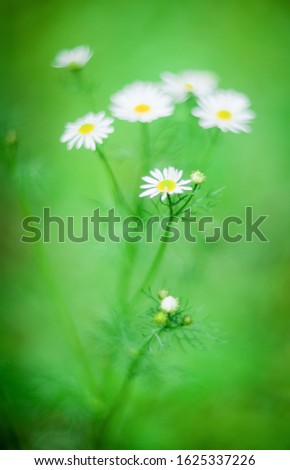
xmin=110 ymin=82 xmax=174 ymax=122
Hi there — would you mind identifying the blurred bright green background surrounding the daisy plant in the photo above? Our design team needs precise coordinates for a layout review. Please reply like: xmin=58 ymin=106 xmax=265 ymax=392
xmin=0 ymin=0 xmax=290 ymax=449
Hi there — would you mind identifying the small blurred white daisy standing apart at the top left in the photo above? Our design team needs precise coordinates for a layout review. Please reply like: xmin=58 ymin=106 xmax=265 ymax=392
xmin=52 ymin=46 xmax=93 ymax=70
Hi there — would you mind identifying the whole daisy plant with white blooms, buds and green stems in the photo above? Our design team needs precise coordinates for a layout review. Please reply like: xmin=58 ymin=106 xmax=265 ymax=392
xmin=52 ymin=46 xmax=251 ymax=426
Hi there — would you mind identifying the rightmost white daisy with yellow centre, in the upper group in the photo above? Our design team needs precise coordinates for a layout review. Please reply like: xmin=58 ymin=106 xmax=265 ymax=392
xmin=192 ymin=90 xmax=255 ymax=133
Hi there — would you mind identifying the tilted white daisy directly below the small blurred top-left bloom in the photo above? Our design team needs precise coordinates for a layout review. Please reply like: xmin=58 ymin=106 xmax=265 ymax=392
xmin=60 ymin=111 xmax=114 ymax=150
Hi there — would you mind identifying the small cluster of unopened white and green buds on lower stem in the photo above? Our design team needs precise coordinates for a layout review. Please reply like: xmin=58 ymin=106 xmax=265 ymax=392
xmin=153 ymin=290 xmax=192 ymax=329
